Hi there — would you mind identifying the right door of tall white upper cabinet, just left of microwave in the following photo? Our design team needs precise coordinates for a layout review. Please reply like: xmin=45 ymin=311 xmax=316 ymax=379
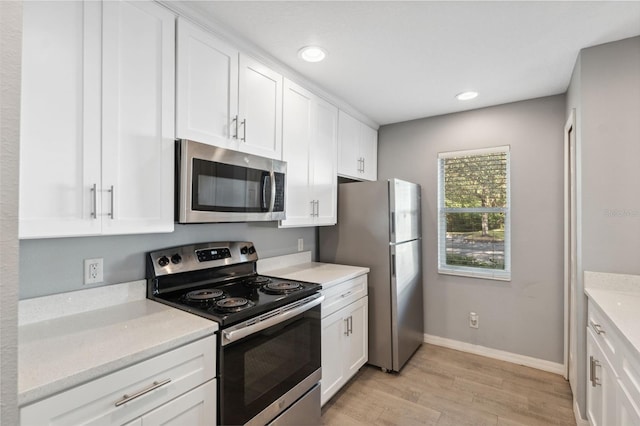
xmin=102 ymin=1 xmax=175 ymax=234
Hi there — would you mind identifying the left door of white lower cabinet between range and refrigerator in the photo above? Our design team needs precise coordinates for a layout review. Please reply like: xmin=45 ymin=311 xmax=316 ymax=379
xmin=320 ymin=308 xmax=347 ymax=405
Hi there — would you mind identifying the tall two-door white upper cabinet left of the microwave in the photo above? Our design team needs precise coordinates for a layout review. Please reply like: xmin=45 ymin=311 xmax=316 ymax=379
xmin=19 ymin=1 xmax=174 ymax=238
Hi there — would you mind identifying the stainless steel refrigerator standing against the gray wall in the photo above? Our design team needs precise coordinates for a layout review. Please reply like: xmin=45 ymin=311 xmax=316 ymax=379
xmin=319 ymin=179 xmax=424 ymax=371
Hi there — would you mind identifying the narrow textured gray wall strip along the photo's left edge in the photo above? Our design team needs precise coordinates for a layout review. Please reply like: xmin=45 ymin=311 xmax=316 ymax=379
xmin=0 ymin=2 xmax=22 ymax=425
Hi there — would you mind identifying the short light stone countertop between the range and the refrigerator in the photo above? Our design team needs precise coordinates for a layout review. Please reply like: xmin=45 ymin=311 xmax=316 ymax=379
xmin=258 ymin=252 xmax=369 ymax=290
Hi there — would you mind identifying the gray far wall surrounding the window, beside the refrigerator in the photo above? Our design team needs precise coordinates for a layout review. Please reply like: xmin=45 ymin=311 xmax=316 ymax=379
xmin=378 ymin=95 xmax=565 ymax=363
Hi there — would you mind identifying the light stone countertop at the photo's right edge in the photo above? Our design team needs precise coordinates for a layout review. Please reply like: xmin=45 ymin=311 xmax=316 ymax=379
xmin=584 ymin=271 xmax=640 ymax=353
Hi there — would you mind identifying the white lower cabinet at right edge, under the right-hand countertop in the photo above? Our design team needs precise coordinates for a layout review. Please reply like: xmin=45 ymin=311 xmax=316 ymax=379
xmin=587 ymin=300 xmax=640 ymax=426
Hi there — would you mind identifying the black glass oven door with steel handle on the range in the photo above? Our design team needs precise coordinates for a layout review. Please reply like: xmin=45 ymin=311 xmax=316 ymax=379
xmin=218 ymin=294 xmax=324 ymax=425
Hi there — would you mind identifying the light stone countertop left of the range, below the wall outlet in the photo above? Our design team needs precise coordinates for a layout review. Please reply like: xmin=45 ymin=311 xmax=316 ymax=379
xmin=18 ymin=281 xmax=218 ymax=406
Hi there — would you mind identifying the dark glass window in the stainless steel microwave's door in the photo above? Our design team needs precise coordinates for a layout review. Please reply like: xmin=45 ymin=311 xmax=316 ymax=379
xmin=192 ymin=158 xmax=271 ymax=213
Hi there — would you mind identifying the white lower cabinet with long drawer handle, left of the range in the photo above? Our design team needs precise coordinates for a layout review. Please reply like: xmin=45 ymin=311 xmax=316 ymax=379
xmin=20 ymin=336 xmax=216 ymax=426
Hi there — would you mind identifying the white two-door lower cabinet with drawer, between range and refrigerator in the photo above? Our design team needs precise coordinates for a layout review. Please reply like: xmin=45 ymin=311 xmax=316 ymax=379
xmin=320 ymin=275 xmax=369 ymax=405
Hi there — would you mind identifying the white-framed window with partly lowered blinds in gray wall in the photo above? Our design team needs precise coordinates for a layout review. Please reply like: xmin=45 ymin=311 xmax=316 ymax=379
xmin=438 ymin=146 xmax=511 ymax=280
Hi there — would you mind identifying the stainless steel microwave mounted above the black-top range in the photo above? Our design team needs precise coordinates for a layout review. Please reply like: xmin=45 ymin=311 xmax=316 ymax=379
xmin=176 ymin=139 xmax=287 ymax=223
